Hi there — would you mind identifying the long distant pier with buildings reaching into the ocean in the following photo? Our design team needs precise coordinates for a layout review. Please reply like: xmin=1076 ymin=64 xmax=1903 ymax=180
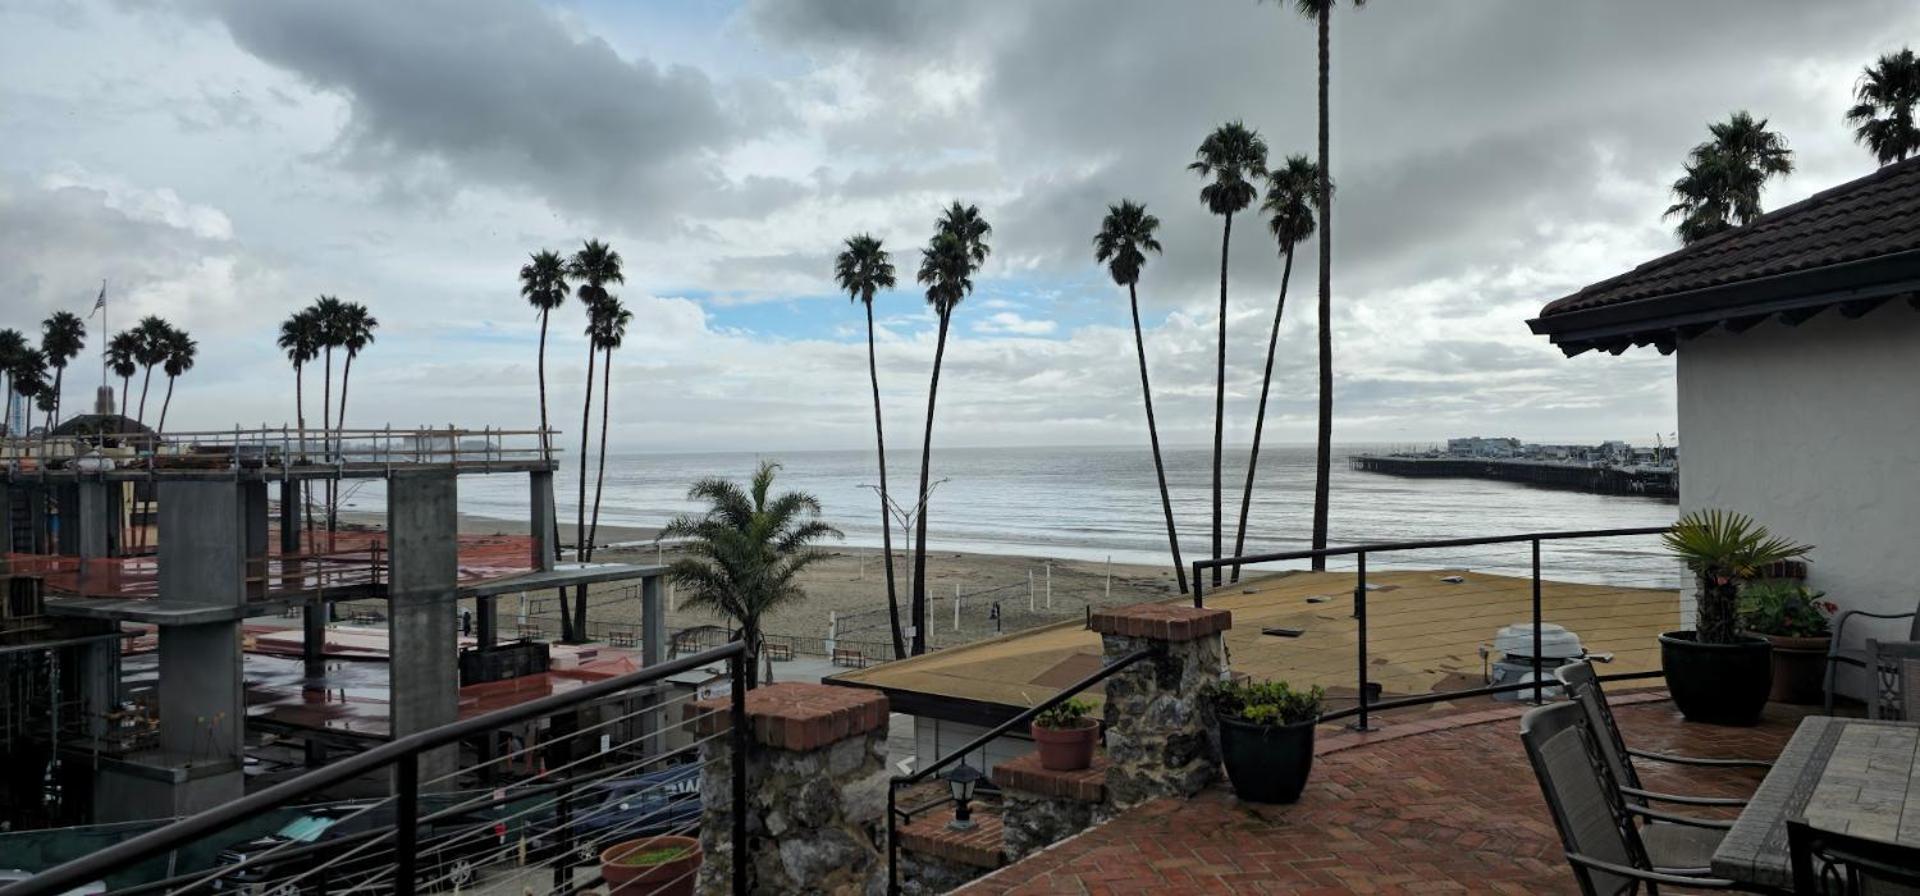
xmin=1348 ymin=437 xmax=1680 ymax=501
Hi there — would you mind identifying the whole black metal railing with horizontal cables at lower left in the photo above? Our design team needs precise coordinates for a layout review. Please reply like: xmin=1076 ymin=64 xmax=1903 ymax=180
xmin=0 ymin=641 xmax=749 ymax=896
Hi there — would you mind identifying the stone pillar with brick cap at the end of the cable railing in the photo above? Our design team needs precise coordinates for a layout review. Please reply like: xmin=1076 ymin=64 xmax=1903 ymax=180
xmin=685 ymin=681 xmax=887 ymax=894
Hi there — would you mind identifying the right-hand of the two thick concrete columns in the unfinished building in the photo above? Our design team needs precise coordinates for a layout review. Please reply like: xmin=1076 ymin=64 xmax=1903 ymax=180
xmin=386 ymin=470 xmax=459 ymax=787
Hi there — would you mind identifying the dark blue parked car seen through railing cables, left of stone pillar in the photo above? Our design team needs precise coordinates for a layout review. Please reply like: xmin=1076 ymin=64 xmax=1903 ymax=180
xmin=526 ymin=764 xmax=701 ymax=863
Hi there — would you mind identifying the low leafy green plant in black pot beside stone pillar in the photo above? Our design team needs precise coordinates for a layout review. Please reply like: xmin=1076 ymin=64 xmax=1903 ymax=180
xmin=1206 ymin=681 xmax=1327 ymax=802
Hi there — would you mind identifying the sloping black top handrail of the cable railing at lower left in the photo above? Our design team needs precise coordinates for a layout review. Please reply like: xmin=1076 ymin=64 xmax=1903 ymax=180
xmin=0 ymin=641 xmax=747 ymax=896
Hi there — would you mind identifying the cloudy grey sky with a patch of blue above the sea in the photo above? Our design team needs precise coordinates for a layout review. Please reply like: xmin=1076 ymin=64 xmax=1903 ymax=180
xmin=0 ymin=0 xmax=1920 ymax=451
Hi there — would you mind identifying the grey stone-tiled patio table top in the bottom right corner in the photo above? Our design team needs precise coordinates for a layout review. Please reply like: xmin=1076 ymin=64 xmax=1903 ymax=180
xmin=1713 ymin=716 xmax=1920 ymax=888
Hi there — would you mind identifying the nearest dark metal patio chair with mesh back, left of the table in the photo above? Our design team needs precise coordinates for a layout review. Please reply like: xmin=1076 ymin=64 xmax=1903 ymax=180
xmin=1521 ymin=702 xmax=1747 ymax=896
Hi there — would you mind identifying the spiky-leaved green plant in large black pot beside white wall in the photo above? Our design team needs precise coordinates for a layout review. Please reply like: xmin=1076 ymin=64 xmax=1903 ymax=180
xmin=1661 ymin=510 xmax=1812 ymax=725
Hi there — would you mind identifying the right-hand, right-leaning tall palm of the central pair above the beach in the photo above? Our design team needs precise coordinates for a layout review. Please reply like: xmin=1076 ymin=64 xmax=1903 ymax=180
xmin=912 ymin=201 xmax=993 ymax=656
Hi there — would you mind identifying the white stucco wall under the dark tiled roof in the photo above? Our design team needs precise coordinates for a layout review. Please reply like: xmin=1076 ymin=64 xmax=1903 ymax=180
xmin=1678 ymin=301 xmax=1920 ymax=679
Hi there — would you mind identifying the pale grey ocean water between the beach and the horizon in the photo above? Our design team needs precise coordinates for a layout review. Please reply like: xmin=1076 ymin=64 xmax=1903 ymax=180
xmin=344 ymin=439 xmax=1678 ymax=583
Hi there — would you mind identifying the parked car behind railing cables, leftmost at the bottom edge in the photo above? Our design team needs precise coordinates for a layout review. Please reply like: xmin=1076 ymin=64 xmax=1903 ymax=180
xmin=211 ymin=804 xmax=507 ymax=896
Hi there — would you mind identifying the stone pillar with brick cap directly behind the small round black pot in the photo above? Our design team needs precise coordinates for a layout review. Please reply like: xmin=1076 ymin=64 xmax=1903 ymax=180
xmin=1092 ymin=604 xmax=1233 ymax=808
